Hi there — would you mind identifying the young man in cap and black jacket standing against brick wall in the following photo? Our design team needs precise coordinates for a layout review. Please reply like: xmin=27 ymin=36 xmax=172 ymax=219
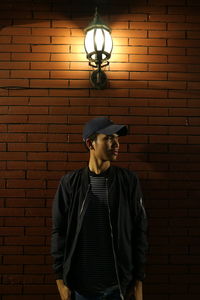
xmin=51 ymin=117 xmax=147 ymax=300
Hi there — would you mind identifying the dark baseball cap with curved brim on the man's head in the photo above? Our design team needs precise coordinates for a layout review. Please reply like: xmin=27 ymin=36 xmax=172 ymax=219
xmin=83 ymin=117 xmax=128 ymax=141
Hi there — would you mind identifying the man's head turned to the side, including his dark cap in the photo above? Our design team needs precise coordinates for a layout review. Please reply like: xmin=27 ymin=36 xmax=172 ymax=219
xmin=83 ymin=117 xmax=128 ymax=161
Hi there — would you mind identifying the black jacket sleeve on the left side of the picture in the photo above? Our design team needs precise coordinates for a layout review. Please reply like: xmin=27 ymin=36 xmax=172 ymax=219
xmin=51 ymin=176 xmax=69 ymax=279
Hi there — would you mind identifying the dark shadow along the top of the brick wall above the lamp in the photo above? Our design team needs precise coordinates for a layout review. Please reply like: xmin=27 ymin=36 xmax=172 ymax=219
xmin=0 ymin=0 xmax=140 ymax=29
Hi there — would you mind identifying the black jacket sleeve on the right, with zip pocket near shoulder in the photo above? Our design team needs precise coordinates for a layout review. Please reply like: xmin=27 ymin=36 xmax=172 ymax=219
xmin=132 ymin=174 xmax=148 ymax=281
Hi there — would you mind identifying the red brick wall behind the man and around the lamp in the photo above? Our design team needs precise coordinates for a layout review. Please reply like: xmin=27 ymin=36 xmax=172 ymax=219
xmin=0 ymin=0 xmax=200 ymax=300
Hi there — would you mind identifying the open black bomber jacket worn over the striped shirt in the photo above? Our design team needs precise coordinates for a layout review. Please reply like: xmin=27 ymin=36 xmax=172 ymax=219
xmin=51 ymin=166 xmax=148 ymax=299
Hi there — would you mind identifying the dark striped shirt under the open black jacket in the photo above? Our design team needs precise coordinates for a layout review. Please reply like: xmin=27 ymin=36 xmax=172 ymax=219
xmin=70 ymin=169 xmax=117 ymax=294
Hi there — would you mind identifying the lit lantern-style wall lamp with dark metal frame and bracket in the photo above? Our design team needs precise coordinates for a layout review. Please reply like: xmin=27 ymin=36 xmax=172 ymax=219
xmin=84 ymin=8 xmax=113 ymax=89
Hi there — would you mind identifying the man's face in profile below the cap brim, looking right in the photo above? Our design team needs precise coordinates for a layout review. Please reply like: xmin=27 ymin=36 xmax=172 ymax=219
xmin=92 ymin=133 xmax=119 ymax=161
